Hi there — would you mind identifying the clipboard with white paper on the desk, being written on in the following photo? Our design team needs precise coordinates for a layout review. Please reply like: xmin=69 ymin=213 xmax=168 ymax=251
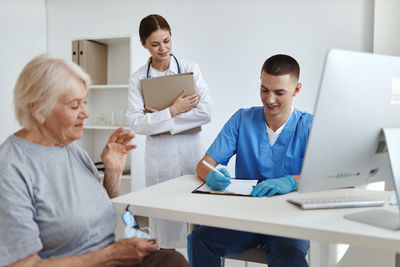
xmin=192 ymin=178 xmax=259 ymax=197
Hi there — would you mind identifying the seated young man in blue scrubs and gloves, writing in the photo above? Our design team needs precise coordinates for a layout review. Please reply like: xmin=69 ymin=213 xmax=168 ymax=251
xmin=188 ymin=55 xmax=313 ymax=267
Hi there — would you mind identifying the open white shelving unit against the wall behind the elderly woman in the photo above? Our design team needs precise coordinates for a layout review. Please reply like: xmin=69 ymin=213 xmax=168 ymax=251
xmin=73 ymin=37 xmax=131 ymax=194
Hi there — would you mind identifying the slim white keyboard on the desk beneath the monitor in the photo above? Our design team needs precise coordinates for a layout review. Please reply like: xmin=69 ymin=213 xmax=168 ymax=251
xmin=287 ymin=196 xmax=385 ymax=210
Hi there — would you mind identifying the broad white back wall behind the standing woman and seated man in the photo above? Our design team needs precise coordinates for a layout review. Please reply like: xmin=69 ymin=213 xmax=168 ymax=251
xmin=47 ymin=0 xmax=374 ymax=189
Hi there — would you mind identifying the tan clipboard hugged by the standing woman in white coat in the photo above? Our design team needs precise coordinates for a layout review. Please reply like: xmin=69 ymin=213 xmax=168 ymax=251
xmin=140 ymin=72 xmax=201 ymax=136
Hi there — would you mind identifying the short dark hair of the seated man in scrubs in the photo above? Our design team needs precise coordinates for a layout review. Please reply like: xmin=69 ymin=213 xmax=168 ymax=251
xmin=262 ymin=54 xmax=300 ymax=81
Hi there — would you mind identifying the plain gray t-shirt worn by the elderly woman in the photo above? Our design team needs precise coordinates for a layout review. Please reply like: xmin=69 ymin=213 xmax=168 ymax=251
xmin=0 ymin=135 xmax=116 ymax=266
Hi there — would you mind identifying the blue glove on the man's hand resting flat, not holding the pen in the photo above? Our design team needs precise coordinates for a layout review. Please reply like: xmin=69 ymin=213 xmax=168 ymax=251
xmin=251 ymin=175 xmax=297 ymax=197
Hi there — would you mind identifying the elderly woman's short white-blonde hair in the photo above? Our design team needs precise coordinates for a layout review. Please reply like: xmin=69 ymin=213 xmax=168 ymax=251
xmin=14 ymin=54 xmax=91 ymax=130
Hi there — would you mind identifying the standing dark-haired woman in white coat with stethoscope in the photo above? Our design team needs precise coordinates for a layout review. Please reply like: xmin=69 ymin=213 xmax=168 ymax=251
xmin=126 ymin=15 xmax=211 ymax=248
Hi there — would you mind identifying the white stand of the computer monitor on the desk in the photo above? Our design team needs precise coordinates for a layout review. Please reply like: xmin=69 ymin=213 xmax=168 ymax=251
xmin=344 ymin=128 xmax=400 ymax=230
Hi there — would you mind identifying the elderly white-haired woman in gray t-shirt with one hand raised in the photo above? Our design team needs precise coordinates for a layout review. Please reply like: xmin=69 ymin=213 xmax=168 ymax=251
xmin=0 ymin=55 xmax=189 ymax=266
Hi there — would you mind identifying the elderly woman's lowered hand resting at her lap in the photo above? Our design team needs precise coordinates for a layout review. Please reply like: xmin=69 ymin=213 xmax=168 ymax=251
xmin=110 ymin=237 xmax=158 ymax=266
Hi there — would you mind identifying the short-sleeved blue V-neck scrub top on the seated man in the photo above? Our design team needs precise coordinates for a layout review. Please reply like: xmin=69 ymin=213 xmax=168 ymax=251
xmin=207 ymin=107 xmax=313 ymax=179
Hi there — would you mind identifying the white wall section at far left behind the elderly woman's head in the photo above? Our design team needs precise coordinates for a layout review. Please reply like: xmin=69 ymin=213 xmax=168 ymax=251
xmin=0 ymin=0 xmax=47 ymax=143
